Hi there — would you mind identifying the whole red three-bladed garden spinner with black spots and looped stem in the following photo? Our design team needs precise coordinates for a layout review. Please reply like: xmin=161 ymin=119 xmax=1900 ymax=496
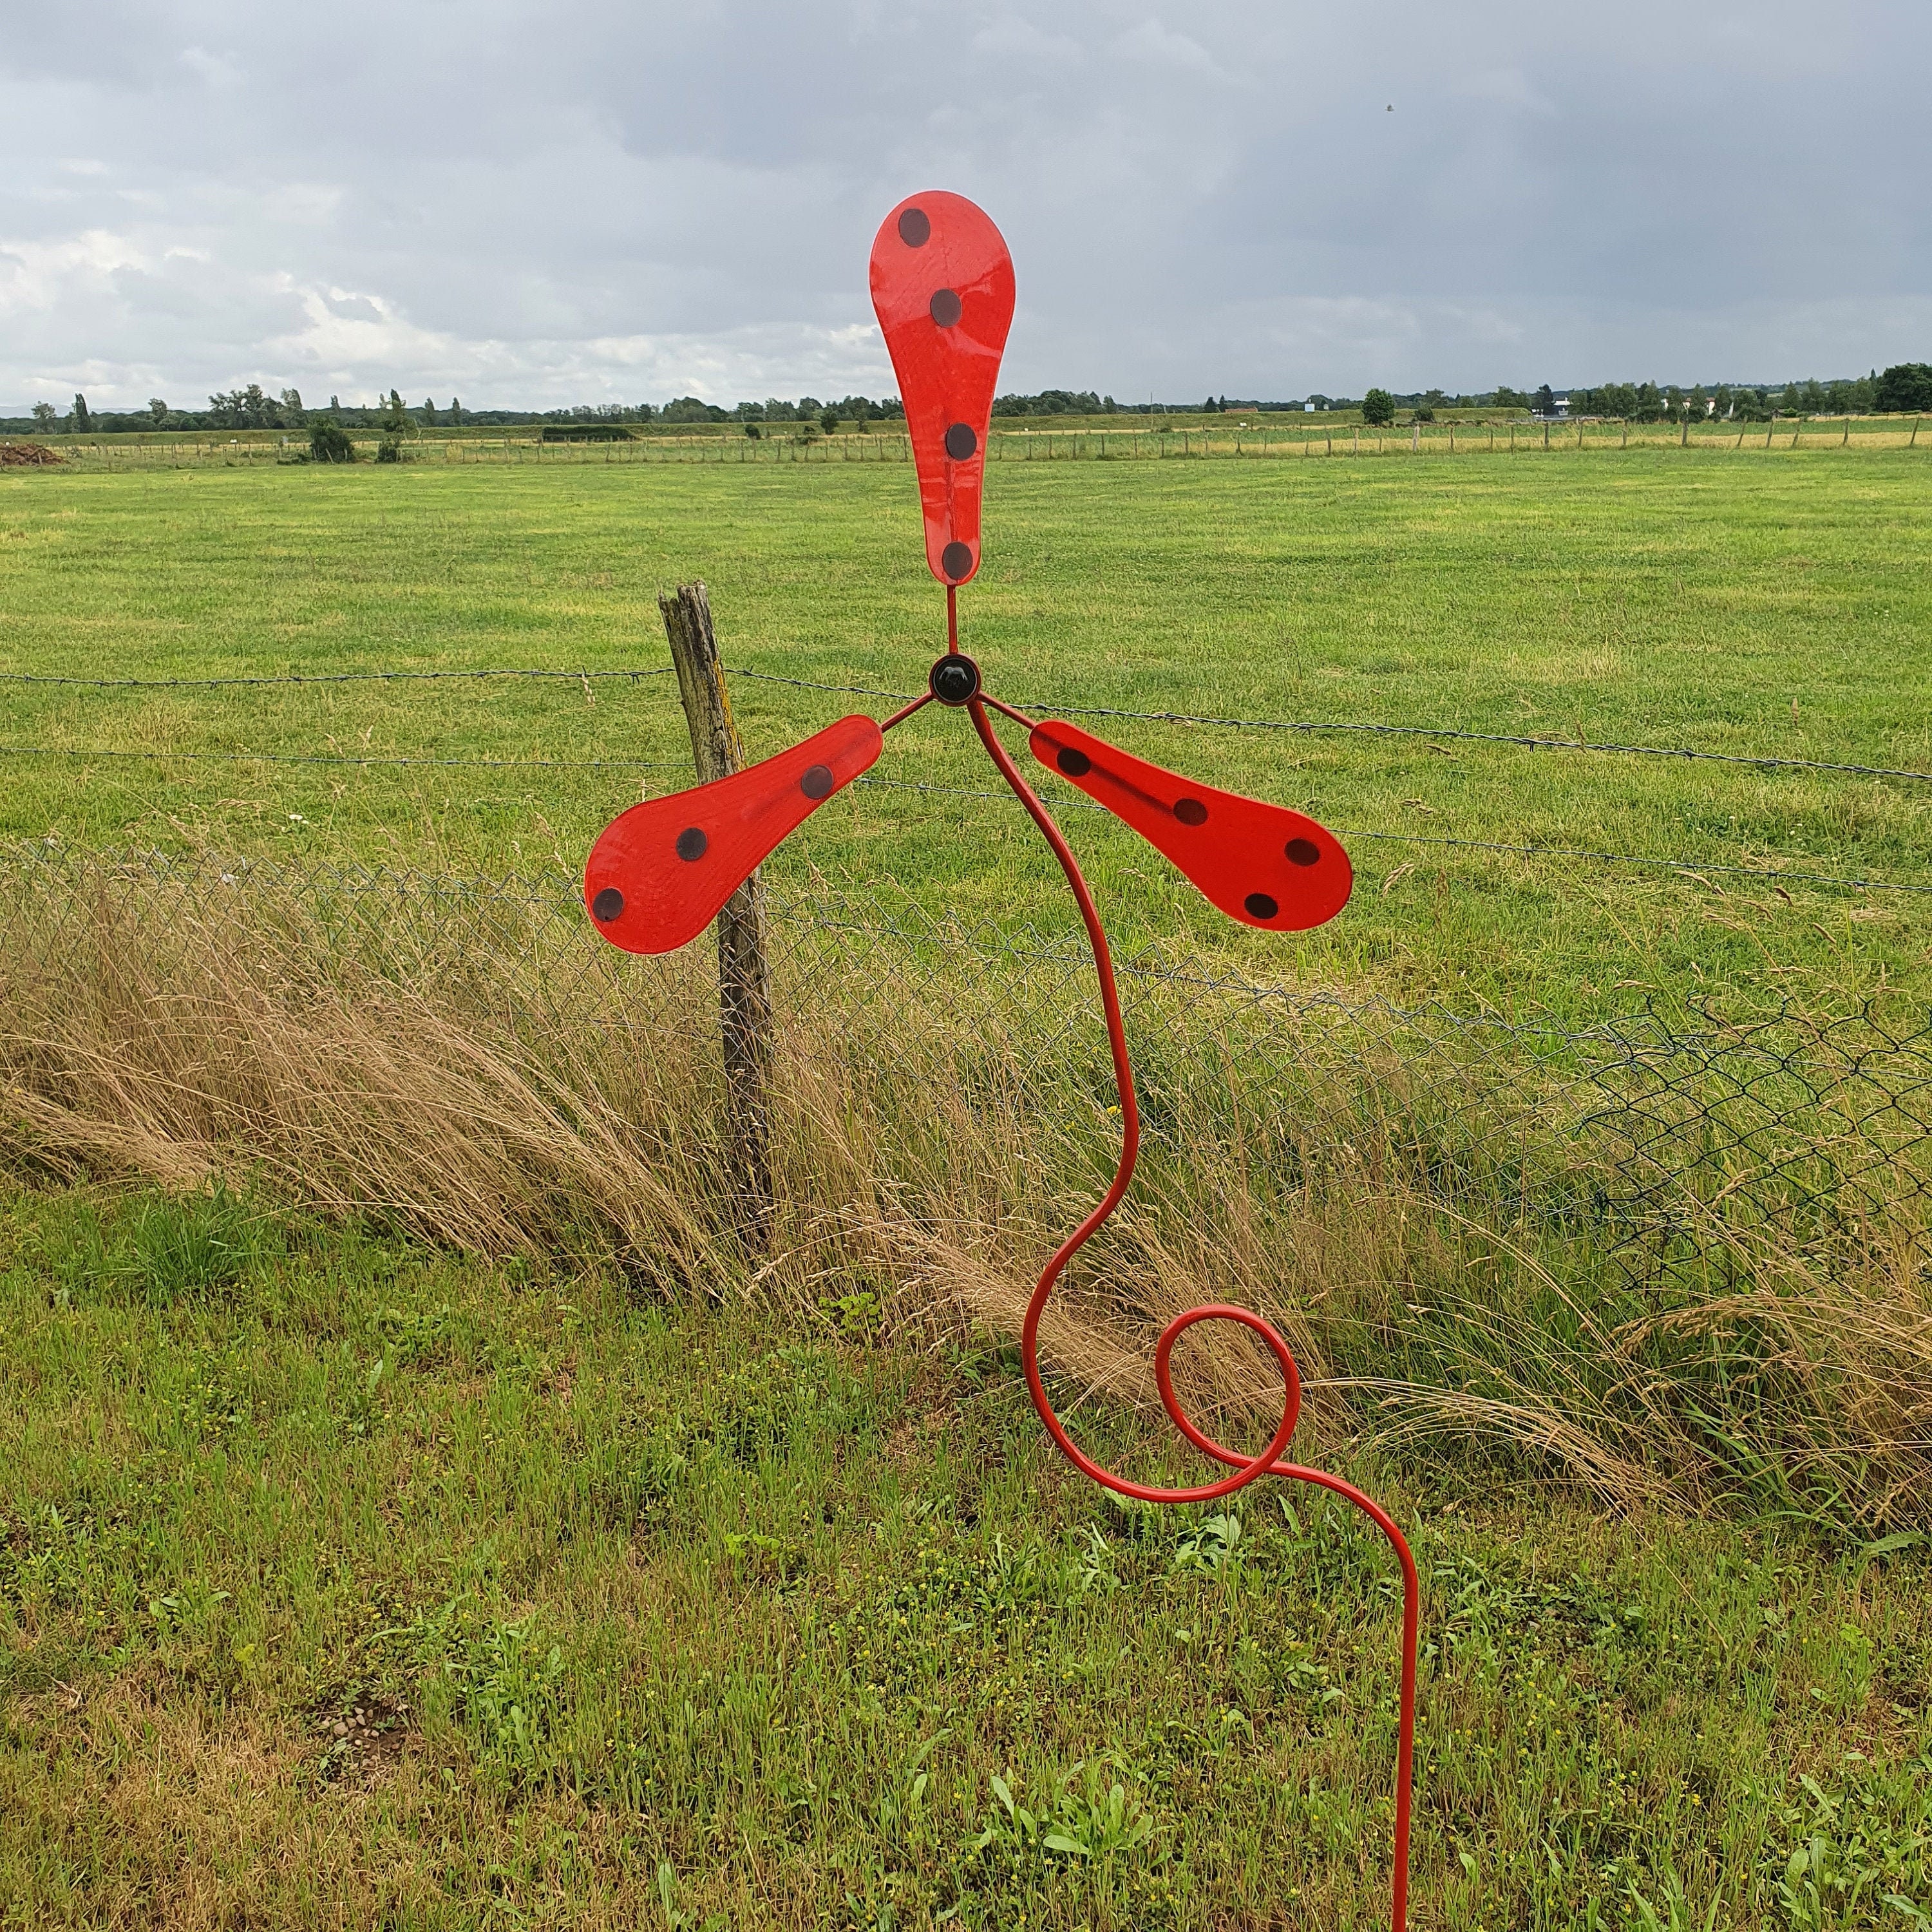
xmin=583 ymin=193 xmax=1420 ymax=1932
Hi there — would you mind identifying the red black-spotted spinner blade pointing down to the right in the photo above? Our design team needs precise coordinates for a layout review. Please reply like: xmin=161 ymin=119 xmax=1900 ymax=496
xmin=1032 ymin=719 xmax=1354 ymax=933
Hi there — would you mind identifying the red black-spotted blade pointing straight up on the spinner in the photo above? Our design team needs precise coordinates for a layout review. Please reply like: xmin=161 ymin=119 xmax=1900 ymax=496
xmin=871 ymin=189 xmax=1012 ymax=583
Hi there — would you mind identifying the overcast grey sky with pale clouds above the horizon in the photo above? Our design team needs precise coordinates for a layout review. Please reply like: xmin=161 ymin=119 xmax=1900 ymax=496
xmin=0 ymin=0 xmax=1932 ymax=410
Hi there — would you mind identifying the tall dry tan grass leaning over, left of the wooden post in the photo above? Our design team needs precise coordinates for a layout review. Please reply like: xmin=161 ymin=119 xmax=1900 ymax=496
xmin=0 ymin=885 xmax=724 ymax=1287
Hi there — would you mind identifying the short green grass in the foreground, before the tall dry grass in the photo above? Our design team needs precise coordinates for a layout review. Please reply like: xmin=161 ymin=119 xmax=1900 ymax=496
xmin=0 ymin=1190 xmax=1932 ymax=1932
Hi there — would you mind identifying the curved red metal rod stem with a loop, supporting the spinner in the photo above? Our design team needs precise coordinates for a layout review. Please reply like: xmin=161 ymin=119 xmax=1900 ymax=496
xmin=966 ymin=697 xmax=1422 ymax=1932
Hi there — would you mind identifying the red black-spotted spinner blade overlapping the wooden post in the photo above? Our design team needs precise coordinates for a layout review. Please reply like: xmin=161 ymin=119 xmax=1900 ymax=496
xmin=583 ymin=717 xmax=879 ymax=952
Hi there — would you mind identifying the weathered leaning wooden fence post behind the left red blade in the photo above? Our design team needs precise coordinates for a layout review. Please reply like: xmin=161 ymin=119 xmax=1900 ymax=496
xmin=657 ymin=583 xmax=773 ymax=1254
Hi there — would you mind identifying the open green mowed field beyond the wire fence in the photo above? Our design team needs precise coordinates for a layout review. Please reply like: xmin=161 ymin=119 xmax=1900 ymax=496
xmin=0 ymin=450 xmax=1932 ymax=1016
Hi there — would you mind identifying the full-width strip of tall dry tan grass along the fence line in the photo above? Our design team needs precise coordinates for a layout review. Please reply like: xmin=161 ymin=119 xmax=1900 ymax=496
xmin=0 ymin=862 xmax=1932 ymax=1522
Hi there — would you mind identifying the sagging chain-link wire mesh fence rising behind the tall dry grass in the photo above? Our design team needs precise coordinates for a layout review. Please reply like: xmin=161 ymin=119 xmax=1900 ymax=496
xmin=0 ymin=842 xmax=1932 ymax=1279
